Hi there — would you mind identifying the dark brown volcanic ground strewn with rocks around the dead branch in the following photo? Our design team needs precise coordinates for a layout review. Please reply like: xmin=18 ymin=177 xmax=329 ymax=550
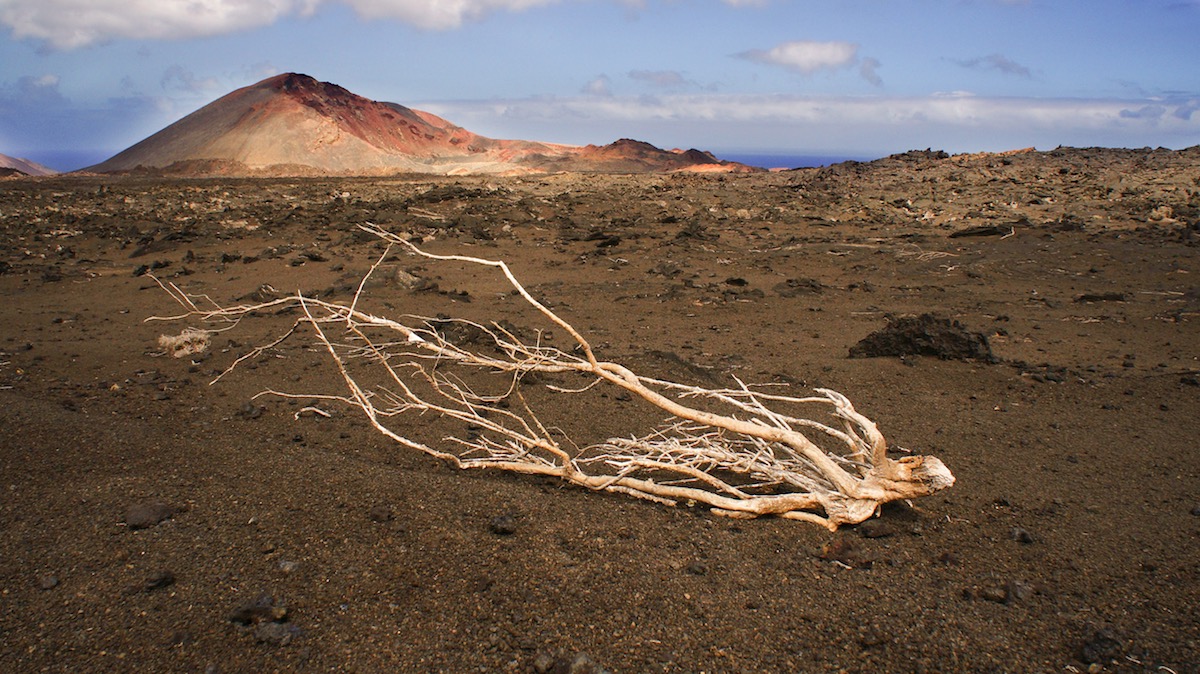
xmin=0 ymin=149 xmax=1200 ymax=673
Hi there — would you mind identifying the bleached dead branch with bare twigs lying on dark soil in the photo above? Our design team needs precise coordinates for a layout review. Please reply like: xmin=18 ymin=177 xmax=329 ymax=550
xmin=150 ymin=225 xmax=954 ymax=529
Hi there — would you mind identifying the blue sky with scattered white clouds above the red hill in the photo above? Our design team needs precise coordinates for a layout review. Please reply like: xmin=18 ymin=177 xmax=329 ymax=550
xmin=0 ymin=0 xmax=1200 ymax=170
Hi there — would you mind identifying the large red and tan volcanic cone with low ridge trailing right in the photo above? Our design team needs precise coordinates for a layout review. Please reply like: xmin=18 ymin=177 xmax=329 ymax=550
xmin=84 ymin=73 xmax=750 ymax=175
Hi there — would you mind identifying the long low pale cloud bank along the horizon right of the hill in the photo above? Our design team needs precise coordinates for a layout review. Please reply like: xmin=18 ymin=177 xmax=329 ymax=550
xmin=414 ymin=92 xmax=1200 ymax=155
